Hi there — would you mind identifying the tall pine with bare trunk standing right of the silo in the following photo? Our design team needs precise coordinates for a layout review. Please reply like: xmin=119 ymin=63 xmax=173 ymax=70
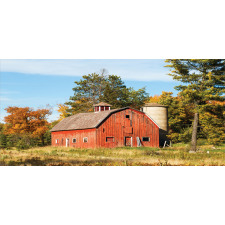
xmin=166 ymin=59 xmax=225 ymax=151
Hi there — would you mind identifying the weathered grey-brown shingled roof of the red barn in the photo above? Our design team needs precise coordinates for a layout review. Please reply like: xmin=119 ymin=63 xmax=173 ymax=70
xmin=51 ymin=107 xmax=158 ymax=131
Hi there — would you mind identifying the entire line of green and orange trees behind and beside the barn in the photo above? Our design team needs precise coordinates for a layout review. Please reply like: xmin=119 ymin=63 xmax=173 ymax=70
xmin=0 ymin=59 xmax=225 ymax=151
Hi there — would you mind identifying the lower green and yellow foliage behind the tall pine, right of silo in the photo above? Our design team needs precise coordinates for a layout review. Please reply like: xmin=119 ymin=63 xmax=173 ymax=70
xmin=150 ymin=92 xmax=225 ymax=145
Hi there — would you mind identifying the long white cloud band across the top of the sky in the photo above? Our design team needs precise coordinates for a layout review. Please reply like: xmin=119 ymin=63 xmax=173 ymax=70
xmin=0 ymin=59 xmax=172 ymax=81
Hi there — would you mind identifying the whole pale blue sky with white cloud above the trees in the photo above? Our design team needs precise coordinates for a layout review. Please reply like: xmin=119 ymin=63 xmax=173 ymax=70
xmin=0 ymin=59 xmax=178 ymax=122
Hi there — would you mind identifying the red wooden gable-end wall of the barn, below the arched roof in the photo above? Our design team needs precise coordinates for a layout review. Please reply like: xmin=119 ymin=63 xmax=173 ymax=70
xmin=96 ymin=109 xmax=159 ymax=148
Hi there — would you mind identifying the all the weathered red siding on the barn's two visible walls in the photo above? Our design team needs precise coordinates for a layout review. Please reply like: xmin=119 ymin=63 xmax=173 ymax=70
xmin=52 ymin=109 xmax=159 ymax=148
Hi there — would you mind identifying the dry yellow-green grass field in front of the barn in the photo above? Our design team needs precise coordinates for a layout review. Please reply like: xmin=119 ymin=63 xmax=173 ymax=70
xmin=0 ymin=144 xmax=225 ymax=166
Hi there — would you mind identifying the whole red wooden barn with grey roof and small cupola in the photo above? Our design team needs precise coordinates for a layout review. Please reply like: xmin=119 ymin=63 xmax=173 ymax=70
xmin=51 ymin=103 xmax=159 ymax=148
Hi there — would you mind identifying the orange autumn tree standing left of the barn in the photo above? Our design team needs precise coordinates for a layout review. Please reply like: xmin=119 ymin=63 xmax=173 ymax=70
xmin=4 ymin=107 xmax=51 ymax=145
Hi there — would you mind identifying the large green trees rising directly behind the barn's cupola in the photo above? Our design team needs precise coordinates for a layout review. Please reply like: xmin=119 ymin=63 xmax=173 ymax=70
xmin=65 ymin=71 xmax=148 ymax=115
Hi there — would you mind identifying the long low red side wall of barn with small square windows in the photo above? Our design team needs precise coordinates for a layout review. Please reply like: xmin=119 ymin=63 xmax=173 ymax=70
xmin=52 ymin=128 xmax=96 ymax=148
